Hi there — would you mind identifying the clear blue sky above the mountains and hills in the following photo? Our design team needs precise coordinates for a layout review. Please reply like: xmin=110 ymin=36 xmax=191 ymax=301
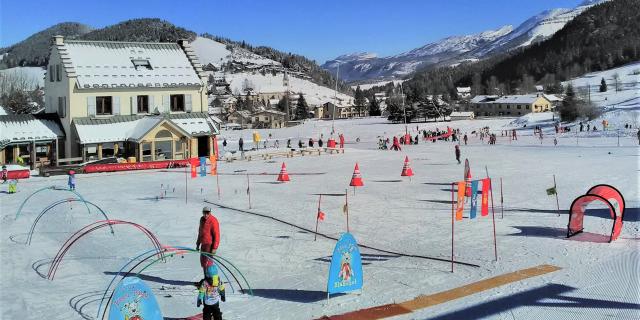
xmin=0 ymin=0 xmax=582 ymax=63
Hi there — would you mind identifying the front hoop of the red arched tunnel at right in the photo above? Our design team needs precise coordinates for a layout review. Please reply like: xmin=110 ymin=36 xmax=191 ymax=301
xmin=567 ymin=194 xmax=622 ymax=242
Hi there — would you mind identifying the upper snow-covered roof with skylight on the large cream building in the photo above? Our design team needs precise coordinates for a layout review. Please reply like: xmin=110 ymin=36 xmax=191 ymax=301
xmin=58 ymin=40 xmax=203 ymax=89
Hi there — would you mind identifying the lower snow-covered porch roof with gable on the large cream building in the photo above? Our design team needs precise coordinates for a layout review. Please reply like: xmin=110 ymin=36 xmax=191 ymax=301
xmin=73 ymin=112 xmax=219 ymax=144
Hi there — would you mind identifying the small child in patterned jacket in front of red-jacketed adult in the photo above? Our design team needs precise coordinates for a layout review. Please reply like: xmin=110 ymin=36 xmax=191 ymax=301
xmin=197 ymin=265 xmax=226 ymax=320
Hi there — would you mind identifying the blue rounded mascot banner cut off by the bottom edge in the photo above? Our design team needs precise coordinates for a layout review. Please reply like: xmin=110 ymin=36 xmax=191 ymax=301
xmin=109 ymin=277 xmax=164 ymax=320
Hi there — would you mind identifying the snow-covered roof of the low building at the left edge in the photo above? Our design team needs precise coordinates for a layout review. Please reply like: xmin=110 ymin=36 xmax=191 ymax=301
xmin=0 ymin=114 xmax=64 ymax=144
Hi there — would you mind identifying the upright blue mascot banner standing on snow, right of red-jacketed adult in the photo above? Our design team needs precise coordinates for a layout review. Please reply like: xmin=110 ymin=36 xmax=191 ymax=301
xmin=327 ymin=232 xmax=362 ymax=294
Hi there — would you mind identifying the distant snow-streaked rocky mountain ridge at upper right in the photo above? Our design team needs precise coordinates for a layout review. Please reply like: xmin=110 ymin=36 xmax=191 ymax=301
xmin=322 ymin=0 xmax=607 ymax=81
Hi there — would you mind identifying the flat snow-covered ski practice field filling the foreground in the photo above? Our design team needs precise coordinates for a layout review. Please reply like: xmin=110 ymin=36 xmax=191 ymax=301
xmin=0 ymin=118 xmax=640 ymax=319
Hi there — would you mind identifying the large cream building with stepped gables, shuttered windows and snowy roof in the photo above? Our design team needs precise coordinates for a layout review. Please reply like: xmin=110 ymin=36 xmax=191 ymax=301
xmin=44 ymin=36 xmax=219 ymax=161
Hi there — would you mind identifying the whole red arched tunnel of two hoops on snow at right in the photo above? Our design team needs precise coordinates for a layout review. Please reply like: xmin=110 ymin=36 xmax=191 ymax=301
xmin=567 ymin=184 xmax=625 ymax=242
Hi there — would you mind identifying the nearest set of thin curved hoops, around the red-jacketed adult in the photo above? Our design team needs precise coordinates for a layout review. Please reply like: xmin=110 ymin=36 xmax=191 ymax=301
xmin=96 ymin=246 xmax=253 ymax=319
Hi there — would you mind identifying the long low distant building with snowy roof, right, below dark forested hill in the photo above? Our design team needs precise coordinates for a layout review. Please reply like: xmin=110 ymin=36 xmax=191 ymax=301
xmin=466 ymin=94 xmax=554 ymax=116
